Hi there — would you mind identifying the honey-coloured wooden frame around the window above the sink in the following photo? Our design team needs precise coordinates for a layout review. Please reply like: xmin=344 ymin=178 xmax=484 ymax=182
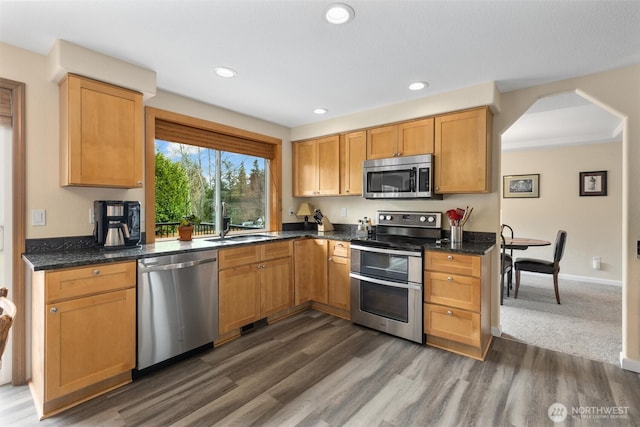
xmin=145 ymin=107 xmax=282 ymax=243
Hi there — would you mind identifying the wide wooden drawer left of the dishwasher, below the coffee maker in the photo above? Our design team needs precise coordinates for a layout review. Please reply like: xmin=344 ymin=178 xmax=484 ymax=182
xmin=45 ymin=262 xmax=136 ymax=302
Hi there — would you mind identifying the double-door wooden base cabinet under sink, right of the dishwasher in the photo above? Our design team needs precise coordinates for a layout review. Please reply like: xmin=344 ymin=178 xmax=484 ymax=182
xmin=218 ymin=240 xmax=293 ymax=335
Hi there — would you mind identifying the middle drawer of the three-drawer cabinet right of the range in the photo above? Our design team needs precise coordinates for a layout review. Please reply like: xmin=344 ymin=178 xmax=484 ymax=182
xmin=424 ymin=271 xmax=480 ymax=311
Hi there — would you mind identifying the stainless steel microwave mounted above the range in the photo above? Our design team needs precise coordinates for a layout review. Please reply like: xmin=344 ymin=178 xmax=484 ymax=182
xmin=362 ymin=154 xmax=442 ymax=199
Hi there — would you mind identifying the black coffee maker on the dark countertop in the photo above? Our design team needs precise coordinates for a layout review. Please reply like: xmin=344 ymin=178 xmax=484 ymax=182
xmin=93 ymin=200 xmax=140 ymax=249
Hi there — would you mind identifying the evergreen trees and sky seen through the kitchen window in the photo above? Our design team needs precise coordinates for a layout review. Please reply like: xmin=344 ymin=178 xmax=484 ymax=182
xmin=155 ymin=139 xmax=269 ymax=238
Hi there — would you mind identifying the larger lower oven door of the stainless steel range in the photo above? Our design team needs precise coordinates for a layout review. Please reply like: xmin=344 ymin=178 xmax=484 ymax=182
xmin=350 ymin=272 xmax=424 ymax=344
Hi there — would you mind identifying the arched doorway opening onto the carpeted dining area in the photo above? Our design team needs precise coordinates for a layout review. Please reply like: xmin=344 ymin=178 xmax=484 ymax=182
xmin=500 ymin=91 xmax=623 ymax=364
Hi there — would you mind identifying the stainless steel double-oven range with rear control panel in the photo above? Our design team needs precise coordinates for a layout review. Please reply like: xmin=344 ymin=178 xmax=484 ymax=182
xmin=349 ymin=211 xmax=442 ymax=343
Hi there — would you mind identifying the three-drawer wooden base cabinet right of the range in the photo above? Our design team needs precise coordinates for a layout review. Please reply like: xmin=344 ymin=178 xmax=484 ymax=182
xmin=424 ymin=251 xmax=491 ymax=360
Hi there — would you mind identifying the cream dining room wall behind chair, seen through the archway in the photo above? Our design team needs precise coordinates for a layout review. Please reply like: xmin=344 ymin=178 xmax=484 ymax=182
xmin=502 ymin=142 xmax=622 ymax=285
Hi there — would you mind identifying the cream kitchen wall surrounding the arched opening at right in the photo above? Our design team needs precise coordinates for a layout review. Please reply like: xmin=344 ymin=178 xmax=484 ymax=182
xmin=492 ymin=65 xmax=640 ymax=372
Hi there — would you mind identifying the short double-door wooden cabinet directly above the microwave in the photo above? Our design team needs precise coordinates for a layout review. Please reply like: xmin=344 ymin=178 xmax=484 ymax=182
xmin=367 ymin=117 xmax=434 ymax=159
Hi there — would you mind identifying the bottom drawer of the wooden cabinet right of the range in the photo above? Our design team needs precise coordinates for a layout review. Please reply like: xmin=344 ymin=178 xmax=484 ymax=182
xmin=424 ymin=304 xmax=480 ymax=347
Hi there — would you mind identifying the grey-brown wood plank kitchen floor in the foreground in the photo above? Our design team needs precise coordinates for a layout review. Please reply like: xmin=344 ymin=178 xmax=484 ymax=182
xmin=0 ymin=311 xmax=640 ymax=427
